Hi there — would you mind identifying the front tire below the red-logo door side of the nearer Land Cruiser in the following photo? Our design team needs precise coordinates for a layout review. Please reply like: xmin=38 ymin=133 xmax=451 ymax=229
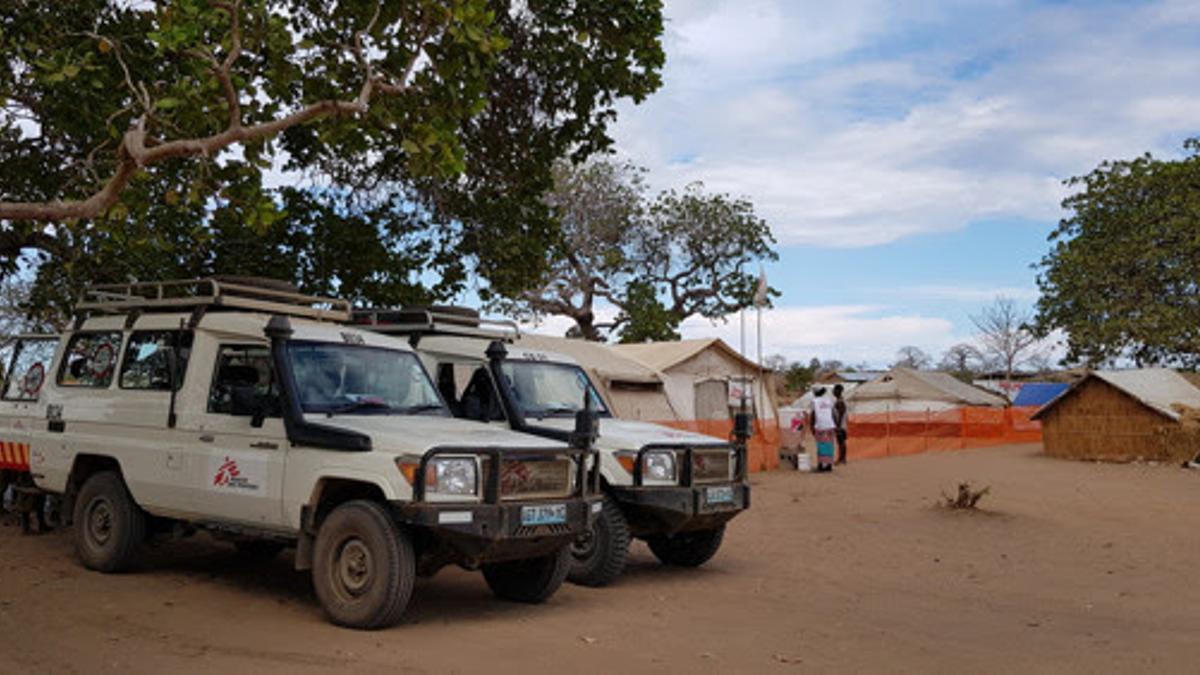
xmin=312 ymin=501 xmax=416 ymax=631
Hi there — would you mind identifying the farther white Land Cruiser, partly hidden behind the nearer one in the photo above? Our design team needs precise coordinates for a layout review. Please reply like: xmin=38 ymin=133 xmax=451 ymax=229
xmin=355 ymin=307 xmax=750 ymax=586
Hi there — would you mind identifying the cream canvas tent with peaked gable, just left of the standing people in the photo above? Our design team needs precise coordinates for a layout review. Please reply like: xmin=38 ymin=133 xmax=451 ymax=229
xmin=612 ymin=339 xmax=780 ymax=470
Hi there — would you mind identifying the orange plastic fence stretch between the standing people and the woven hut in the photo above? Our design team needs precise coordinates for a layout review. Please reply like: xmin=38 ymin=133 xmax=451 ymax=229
xmin=847 ymin=407 xmax=1042 ymax=459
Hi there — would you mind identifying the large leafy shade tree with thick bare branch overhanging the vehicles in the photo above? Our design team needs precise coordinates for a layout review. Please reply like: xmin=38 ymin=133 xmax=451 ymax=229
xmin=0 ymin=0 xmax=662 ymax=312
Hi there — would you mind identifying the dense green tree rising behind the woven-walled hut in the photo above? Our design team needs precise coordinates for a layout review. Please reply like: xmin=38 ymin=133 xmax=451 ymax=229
xmin=1036 ymin=141 xmax=1200 ymax=366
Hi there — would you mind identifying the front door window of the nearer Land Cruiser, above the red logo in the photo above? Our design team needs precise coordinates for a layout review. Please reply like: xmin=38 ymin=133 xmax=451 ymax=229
xmin=209 ymin=345 xmax=282 ymax=417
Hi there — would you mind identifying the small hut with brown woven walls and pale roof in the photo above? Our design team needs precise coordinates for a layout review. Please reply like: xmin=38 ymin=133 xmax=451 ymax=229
xmin=1033 ymin=368 xmax=1200 ymax=461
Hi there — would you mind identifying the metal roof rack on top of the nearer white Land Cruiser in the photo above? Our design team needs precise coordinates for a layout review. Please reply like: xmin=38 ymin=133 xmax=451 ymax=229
xmin=76 ymin=277 xmax=350 ymax=321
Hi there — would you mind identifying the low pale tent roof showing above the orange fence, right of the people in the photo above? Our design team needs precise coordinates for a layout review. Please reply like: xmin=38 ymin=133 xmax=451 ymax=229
xmin=846 ymin=368 xmax=1007 ymax=413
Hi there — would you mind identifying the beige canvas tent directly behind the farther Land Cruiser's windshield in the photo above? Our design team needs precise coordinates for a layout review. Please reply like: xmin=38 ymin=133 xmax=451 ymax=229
xmin=516 ymin=334 xmax=679 ymax=422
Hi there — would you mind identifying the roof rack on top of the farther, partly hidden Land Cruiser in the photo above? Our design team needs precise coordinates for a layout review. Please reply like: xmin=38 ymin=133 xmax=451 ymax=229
xmin=352 ymin=306 xmax=521 ymax=341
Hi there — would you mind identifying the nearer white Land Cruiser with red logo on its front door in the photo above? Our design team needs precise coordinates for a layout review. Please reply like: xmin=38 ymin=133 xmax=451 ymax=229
xmin=0 ymin=279 xmax=600 ymax=628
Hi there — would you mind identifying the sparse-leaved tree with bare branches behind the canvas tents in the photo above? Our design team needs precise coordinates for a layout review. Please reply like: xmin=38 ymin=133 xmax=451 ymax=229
xmin=518 ymin=161 xmax=779 ymax=342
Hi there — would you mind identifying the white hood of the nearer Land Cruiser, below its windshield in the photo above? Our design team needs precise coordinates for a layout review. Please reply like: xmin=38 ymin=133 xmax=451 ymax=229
xmin=305 ymin=414 xmax=565 ymax=454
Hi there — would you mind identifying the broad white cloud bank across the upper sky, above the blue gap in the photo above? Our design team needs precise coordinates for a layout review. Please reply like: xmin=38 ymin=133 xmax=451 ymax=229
xmin=617 ymin=0 xmax=1200 ymax=246
